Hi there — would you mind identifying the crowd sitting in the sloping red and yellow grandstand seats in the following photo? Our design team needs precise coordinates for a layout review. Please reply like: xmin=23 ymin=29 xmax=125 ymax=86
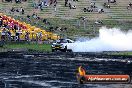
xmin=0 ymin=15 xmax=50 ymax=41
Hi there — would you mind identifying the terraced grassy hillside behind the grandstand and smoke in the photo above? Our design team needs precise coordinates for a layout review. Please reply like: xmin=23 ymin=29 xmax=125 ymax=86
xmin=0 ymin=0 xmax=132 ymax=37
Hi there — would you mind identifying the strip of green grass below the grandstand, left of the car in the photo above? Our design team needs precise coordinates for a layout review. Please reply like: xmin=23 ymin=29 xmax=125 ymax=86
xmin=4 ymin=43 xmax=51 ymax=52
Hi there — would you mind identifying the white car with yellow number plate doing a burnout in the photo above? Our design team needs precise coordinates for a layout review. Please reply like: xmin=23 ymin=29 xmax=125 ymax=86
xmin=51 ymin=39 xmax=74 ymax=52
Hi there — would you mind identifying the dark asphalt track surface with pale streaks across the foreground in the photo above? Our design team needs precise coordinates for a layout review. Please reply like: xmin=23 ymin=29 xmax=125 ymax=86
xmin=0 ymin=53 xmax=132 ymax=88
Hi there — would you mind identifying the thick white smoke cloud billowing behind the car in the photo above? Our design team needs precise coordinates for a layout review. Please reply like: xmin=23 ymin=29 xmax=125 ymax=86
xmin=71 ymin=27 xmax=132 ymax=52
